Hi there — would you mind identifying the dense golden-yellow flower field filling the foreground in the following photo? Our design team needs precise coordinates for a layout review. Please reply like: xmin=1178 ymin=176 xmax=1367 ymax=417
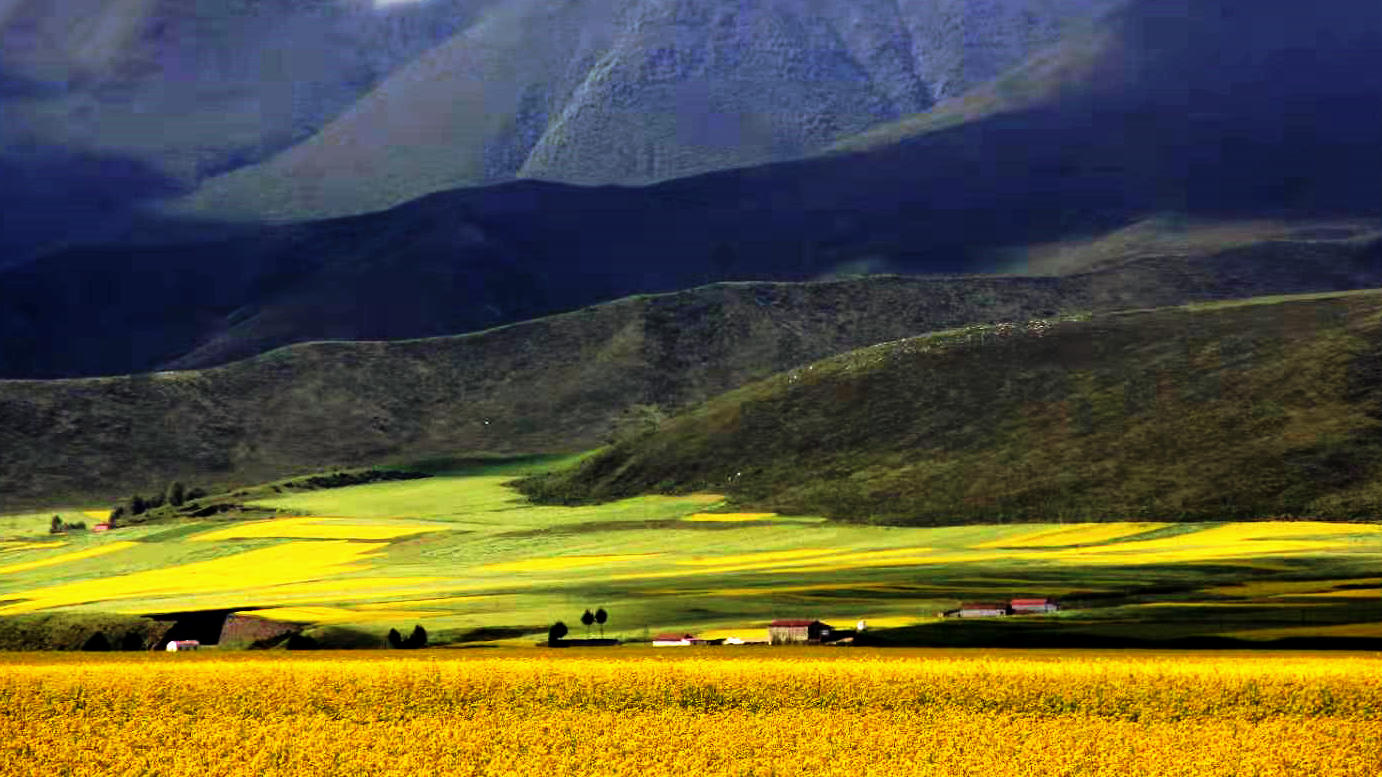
xmin=0 ymin=648 xmax=1382 ymax=777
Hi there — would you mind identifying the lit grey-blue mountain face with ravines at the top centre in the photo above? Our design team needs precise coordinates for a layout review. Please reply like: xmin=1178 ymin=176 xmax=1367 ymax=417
xmin=177 ymin=0 xmax=1122 ymax=220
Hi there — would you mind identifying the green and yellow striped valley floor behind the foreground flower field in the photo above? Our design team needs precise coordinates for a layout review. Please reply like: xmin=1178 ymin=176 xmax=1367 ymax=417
xmin=0 ymin=464 xmax=1382 ymax=644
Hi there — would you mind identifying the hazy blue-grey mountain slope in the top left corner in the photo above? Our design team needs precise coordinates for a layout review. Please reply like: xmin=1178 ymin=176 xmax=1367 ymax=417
xmin=0 ymin=0 xmax=480 ymax=259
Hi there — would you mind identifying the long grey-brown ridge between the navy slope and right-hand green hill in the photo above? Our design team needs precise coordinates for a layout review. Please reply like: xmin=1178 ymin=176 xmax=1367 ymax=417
xmin=8 ymin=237 xmax=1382 ymax=512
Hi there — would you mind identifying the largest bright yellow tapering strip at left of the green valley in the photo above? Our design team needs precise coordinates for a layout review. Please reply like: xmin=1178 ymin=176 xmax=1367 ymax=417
xmin=0 ymin=541 xmax=381 ymax=615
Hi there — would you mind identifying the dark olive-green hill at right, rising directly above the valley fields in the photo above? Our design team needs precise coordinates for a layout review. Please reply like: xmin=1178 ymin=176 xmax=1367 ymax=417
xmin=527 ymin=292 xmax=1382 ymax=524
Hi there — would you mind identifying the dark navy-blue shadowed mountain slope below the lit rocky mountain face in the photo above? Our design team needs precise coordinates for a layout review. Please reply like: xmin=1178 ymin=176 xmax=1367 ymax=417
xmin=8 ymin=0 xmax=1382 ymax=376
